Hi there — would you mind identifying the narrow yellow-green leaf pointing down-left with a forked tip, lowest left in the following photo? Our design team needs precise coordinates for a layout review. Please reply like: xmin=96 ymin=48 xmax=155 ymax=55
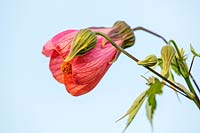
xmin=116 ymin=91 xmax=147 ymax=131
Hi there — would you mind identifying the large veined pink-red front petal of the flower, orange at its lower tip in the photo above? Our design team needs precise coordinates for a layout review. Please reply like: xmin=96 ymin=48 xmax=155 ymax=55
xmin=64 ymin=38 xmax=122 ymax=96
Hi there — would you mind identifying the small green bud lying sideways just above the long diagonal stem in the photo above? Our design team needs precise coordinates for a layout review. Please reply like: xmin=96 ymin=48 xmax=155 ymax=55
xmin=137 ymin=55 xmax=158 ymax=67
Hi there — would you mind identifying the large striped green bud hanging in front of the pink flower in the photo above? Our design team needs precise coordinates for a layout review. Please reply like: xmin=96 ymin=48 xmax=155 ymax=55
xmin=65 ymin=29 xmax=97 ymax=62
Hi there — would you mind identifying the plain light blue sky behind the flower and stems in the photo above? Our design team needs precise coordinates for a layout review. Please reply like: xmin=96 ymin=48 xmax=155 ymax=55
xmin=0 ymin=0 xmax=200 ymax=133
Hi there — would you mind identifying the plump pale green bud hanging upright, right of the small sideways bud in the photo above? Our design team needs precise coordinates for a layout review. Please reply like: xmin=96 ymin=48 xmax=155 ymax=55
xmin=161 ymin=45 xmax=176 ymax=76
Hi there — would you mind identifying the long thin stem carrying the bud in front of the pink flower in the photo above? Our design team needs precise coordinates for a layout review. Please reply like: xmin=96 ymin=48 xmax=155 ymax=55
xmin=95 ymin=32 xmax=190 ymax=99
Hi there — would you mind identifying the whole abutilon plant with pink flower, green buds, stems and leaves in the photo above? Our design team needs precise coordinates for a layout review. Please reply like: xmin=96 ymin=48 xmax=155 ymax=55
xmin=42 ymin=21 xmax=200 ymax=131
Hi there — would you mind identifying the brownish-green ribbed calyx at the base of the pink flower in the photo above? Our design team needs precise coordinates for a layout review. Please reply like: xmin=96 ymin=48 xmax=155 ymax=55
xmin=109 ymin=21 xmax=135 ymax=48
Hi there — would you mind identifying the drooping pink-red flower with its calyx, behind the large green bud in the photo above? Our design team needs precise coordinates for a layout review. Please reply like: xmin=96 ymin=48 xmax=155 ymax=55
xmin=42 ymin=21 xmax=135 ymax=96
